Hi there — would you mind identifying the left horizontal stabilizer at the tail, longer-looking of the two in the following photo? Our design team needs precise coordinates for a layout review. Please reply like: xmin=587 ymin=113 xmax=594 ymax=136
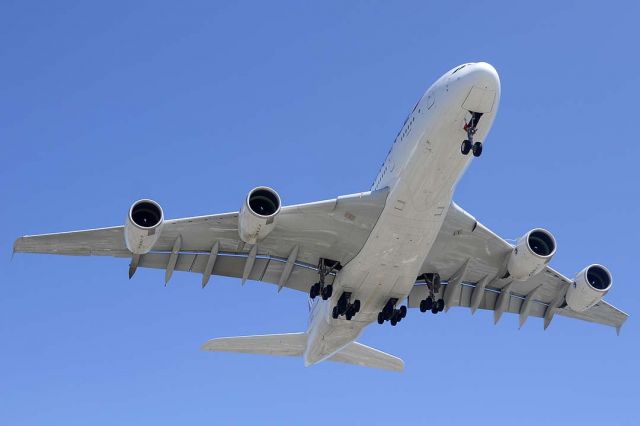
xmin=202 ymin=333 xmax=307 ymax=356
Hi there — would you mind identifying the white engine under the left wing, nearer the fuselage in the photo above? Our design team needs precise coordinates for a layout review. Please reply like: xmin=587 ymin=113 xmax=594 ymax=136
xmin=238 ymin=186 xmax=281 ymax=244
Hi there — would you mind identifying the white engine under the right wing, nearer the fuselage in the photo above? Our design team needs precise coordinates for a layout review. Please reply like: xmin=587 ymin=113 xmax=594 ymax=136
xmin=507 ymin=228 xmax=556 ymax=281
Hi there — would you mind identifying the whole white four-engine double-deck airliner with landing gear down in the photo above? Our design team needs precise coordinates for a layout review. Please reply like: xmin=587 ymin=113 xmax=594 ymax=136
xmin=14 ymin=62 xmax=627 ymax=371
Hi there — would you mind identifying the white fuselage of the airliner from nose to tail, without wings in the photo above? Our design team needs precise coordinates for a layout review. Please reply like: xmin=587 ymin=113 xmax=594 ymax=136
xmin=304 ymin=62 xmax=500 ymax=365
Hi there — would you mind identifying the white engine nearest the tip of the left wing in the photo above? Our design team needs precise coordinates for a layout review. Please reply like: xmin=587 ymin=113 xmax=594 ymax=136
xmin=124 ymin=200 xmax=164 ymax=254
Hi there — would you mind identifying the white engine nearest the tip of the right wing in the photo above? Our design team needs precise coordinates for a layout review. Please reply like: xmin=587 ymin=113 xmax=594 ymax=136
xmin=566 ymin=265 xmax=611 ymax=312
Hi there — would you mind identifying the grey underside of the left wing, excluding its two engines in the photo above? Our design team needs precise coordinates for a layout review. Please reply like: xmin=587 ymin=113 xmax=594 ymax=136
xmin=13 ymin=189 xmax=388 ymax=292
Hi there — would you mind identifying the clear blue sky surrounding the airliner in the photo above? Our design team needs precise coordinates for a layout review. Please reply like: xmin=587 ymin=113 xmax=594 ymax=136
xmin=0 ymin=0 xmax=640 ymax=425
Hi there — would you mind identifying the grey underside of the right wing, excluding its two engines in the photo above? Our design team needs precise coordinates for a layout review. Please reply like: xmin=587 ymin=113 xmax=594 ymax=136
xmin=409 ymin=203 xmax=627 ymax=331
